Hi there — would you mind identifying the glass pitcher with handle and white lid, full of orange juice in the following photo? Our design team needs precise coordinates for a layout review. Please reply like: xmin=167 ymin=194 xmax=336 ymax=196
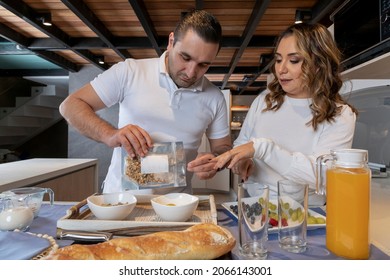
xmin=317 ymin=149 xmax=371 ymax=259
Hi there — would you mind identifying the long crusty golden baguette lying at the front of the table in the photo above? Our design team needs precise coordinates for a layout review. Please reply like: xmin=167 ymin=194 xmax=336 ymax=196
xmin=44 ymin=223 xmax=236 ymax=260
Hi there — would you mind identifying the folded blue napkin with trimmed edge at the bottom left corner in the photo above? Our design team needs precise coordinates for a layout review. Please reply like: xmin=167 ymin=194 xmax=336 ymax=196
xmin=0 ymin=231 xmax=51 ymax=260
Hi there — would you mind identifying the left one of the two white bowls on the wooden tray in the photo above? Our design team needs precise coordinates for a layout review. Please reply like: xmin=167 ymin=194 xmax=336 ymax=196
xmin=87 ymin=192 xmax=137 ymax=220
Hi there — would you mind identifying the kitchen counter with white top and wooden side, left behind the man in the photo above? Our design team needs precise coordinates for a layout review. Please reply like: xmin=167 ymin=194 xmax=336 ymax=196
xmin=0 ymin=158 xmax=98 ymax=201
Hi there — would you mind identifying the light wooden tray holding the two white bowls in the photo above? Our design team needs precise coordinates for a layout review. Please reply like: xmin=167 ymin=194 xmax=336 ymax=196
xmin=57 ymin=195 xmax=217 ymax=236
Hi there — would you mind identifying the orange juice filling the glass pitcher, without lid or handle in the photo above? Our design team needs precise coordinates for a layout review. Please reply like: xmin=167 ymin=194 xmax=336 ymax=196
xmin=326 ymin=168 xmax=371 ymax=259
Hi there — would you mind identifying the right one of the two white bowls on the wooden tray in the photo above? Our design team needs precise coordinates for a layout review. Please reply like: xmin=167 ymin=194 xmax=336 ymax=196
xmin=151 ymin=193 xmax=199 ymax=222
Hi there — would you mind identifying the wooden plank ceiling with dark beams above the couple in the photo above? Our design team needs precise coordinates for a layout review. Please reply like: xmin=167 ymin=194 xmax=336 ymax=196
xmin=0 ymin=0 xmax=344 ymax=93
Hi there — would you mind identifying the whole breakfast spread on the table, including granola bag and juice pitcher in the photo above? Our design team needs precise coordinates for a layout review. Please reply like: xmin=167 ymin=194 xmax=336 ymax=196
xmin=0 ymin=147 xmax=390 ymax=260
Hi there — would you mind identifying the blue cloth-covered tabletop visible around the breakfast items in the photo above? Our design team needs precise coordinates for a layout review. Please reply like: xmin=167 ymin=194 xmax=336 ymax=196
xmin=0 ymin=192 xmax=390 ymax=260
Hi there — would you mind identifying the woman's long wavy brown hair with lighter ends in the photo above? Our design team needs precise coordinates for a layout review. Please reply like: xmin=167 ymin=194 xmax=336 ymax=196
xmin=264 ymin=23 xmax=357 ymax=130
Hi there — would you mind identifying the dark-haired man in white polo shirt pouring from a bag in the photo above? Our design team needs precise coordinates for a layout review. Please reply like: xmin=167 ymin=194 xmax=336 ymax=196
xmin=60 ymin=10 xmax=231 ymax=193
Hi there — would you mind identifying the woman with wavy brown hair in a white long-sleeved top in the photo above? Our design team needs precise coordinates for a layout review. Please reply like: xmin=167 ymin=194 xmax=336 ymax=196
xmin=215 ymin=23 xmax=357 ymax=203
